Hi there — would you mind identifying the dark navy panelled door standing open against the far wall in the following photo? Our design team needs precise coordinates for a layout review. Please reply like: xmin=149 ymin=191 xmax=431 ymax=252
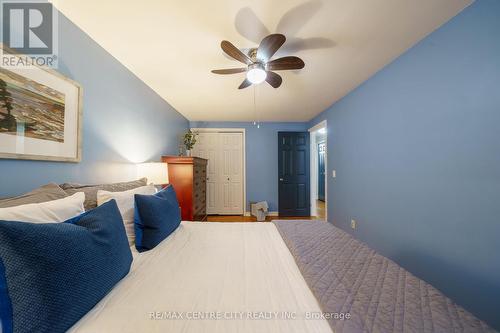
xmin=278 ymin=132 xmax=311 ymax=216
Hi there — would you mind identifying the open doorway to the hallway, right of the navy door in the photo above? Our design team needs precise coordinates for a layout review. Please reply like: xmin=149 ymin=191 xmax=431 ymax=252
xmin=309 ymin=120 xmax=328 ymax=221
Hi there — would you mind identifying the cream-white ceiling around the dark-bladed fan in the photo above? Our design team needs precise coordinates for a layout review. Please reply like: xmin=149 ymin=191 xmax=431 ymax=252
xmin=52 ymin=0 xmax=473 ymax=121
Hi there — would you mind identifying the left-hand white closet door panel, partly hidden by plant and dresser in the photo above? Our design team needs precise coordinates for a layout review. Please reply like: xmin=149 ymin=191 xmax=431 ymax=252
xmin=193 ymin=133 xmax=219 ymax=214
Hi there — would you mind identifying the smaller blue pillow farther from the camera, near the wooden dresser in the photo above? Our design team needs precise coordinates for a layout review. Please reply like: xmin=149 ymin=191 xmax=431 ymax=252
xmin=134 ymin=186 xmax=181 ymax=252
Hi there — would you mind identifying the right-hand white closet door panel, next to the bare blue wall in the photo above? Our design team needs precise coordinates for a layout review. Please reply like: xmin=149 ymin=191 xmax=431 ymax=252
xmin=218 ymin=133 xmax=243 ymax=214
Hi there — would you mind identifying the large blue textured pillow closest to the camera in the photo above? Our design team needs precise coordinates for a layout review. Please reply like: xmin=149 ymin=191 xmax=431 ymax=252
xmin=0 ymin=200 xmax=132 ymax=333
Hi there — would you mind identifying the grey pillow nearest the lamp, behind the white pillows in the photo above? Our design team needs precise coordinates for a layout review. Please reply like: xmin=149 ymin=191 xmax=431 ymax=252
xmin=60 ymin=178 xmax=147 ymax=210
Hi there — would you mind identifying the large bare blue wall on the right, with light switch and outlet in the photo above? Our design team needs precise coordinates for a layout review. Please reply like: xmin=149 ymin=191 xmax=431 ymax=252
xmin=310 ymin=0 xmax=500 ymax=329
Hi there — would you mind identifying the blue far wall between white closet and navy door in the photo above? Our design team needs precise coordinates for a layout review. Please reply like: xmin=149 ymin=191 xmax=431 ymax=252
xmin=190 ymin=122 xmax=308 ymax=211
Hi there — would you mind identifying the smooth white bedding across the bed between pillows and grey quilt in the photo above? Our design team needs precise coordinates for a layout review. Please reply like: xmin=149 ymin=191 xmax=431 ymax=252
xmin=70 ymin=222 xmax=331 ymax=333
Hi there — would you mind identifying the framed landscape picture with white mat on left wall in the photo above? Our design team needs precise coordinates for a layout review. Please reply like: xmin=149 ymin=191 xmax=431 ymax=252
xmin=0 ymin=44 xmax=82 ymax=162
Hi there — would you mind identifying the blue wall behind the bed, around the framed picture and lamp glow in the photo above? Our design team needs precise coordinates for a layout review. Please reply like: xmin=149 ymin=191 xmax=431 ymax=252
xmin=0 ymin=14 xmax=188 ymax=196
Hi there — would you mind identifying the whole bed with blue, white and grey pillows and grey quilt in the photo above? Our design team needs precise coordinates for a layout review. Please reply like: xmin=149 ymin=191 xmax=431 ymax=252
xmin=0 ymin=183 xmax=494 ymax=333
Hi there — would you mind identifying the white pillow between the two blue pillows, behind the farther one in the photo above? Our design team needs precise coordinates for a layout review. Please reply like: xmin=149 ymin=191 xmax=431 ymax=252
xmin=97 ymin=185 xmax=156 ymax=245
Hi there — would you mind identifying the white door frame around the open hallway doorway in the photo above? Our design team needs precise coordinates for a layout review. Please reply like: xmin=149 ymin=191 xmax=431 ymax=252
xmin=309 ymin=119 xmax=328 ymax=221
